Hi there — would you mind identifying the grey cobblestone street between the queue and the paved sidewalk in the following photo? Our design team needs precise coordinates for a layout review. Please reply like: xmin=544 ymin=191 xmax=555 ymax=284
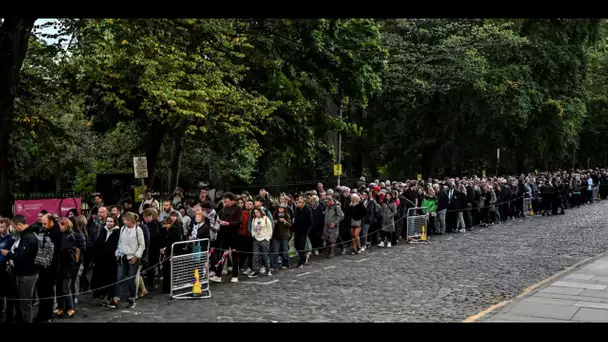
xmin=63 ymin=201 xmax=608 ymax=322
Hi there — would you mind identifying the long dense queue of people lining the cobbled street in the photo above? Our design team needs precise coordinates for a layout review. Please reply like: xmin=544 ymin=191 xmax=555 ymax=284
xmin=0 ymin=169 xmax=608 ymax=322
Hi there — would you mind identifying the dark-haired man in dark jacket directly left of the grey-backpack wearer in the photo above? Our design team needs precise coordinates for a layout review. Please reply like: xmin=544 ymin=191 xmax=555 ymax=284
xmin=0 ymin=215 xmax=39 ymax=323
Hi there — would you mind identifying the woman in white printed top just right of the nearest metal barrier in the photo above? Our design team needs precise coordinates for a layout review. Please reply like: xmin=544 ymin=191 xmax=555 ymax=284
xmin=248 ymin=207 xmax=272 ymax=278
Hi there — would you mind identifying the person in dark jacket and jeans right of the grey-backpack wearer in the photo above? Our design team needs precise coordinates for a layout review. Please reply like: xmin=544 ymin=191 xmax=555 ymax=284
xmin=56 ymin=217 xmax=85 ymax=318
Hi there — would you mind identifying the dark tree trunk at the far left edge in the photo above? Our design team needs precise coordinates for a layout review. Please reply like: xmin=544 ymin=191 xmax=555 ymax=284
xmin=0 ymin=18 xmax=36 ymax=216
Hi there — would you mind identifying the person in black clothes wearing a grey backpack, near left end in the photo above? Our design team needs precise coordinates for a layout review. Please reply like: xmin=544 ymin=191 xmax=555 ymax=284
xmin=34 ymin=214 xmax=63 ymax=323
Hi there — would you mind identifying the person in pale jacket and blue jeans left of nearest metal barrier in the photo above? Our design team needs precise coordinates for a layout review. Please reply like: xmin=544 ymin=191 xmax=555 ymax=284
xmin=107 ymin=212 xmax=146 ymax=309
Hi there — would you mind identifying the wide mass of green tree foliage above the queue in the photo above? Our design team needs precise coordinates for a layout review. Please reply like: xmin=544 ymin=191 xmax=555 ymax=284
xmin=3 ymin=19 xmax=608 ymax=207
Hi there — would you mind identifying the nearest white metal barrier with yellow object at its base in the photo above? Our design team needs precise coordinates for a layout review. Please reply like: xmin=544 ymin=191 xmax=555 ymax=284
xmin=170 ymin=239 xmax=211 ymax=299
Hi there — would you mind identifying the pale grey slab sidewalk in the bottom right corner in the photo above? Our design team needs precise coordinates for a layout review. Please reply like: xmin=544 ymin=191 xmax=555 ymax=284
xmin=482 ymin=254 xmax=608 ymax=322
